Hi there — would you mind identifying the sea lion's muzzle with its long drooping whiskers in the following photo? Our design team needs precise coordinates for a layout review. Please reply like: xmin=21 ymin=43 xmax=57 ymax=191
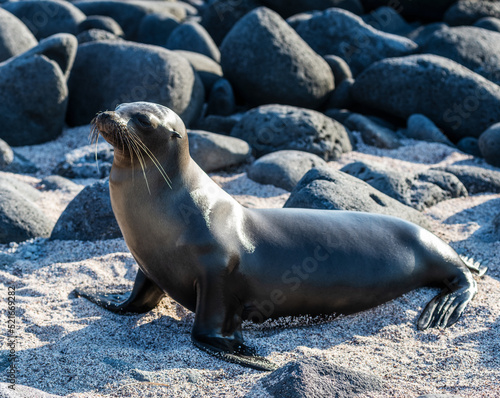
xmin=90 ymin=111 xmax=172 ymax=190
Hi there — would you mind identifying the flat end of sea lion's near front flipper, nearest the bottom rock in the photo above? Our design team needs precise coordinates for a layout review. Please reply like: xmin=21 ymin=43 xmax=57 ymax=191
xmin=191 ymin=336 xmax=278 ymax=371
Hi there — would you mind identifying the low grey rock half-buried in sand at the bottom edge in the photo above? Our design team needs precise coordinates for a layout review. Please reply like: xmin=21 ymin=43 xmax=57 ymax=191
xmin=260 ymin=358 xmax=385 ymax=398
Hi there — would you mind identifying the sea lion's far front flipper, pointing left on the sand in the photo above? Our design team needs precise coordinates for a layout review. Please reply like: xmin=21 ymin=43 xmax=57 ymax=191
xmin=75 ymin=269 xmax=165 ymax=314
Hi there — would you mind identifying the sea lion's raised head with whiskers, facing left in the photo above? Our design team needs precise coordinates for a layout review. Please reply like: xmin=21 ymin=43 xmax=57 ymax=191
xmin=92 ymin=102 xmax=189 ymax=184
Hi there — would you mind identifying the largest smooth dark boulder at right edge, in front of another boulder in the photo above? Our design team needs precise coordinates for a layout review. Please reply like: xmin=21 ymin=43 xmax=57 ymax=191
xmin=353 ymin=54 xmax=500 ymax=141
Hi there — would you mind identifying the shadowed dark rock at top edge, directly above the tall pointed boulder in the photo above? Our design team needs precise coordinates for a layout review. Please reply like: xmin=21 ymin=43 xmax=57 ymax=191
xmin=261 ymin=0 xmax=363 ymax=18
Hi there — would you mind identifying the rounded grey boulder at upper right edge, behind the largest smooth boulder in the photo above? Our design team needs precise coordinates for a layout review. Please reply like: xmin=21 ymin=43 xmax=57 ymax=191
xmin=420 ymin=26 xmax=500 ymax=84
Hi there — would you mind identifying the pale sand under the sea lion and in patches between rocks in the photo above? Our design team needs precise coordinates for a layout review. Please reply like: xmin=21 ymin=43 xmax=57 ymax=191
xmin=0 ymin=129 xmax=500 ymax=398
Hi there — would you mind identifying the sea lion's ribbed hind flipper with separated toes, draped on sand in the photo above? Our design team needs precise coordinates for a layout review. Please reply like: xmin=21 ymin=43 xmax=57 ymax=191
xmin=417 ymin=275 xmax=477 ymax=330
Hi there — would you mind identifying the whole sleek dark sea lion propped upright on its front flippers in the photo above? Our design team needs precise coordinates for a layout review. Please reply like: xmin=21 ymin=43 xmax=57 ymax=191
xmin=77 ymin=102 xmax=484 ymax=370
